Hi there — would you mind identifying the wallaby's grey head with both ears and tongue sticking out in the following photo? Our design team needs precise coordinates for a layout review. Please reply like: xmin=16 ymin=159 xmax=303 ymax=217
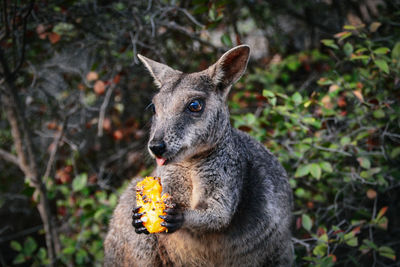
xmin=139 ymin=45 xmax=250 ymax=165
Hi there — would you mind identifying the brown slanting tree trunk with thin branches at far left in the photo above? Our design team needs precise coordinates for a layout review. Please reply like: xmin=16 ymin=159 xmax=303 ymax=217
xmin=0 ymin=0 xmax=60 ymax=267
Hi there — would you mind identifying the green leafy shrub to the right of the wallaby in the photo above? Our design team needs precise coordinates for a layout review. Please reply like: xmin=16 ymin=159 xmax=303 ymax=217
xmin=231 ymin=25 xmax=400 ymax=266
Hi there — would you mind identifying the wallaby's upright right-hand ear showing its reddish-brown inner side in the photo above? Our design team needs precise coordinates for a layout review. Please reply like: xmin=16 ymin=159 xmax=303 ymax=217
xmin=210 ymin=45 xmax=250 ymax=95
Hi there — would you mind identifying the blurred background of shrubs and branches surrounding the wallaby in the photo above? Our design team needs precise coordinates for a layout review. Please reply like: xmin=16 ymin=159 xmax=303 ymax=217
xmin=0 ymin=0 xmax=400 ymax=266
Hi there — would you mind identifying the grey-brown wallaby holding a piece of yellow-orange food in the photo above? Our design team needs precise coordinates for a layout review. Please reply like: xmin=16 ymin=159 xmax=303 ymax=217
xmin=104 ymin=45 xmax=293 ymax=267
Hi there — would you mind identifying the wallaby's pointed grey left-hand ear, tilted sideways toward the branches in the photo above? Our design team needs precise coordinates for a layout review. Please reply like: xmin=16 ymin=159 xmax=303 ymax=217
xmin=138 ymin=55 xmax=180 ymax=88
